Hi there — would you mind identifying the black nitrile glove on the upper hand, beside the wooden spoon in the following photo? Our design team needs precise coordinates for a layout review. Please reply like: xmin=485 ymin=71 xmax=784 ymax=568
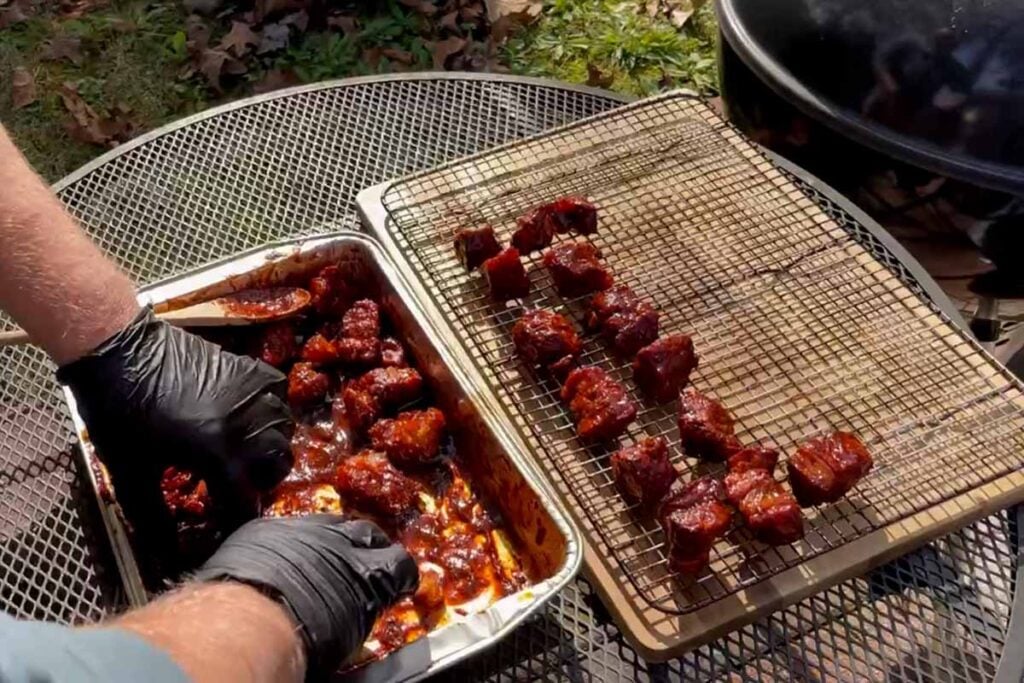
xmin=57 ymin=310 xmax=292 ymax=530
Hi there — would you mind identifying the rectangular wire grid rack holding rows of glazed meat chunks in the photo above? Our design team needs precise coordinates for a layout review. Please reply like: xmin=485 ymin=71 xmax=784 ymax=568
xmin=374 ymin=94 xmax=1024 ymax=614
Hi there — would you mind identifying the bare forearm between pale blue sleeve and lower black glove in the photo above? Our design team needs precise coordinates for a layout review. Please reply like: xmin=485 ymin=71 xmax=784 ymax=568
xmin=108 ymin=583 xmax=306 ymax=683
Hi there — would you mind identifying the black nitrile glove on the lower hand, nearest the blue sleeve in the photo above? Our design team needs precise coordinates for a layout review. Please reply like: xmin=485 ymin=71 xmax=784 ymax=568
xmin=194 ymin=514 xmax=419 ymax=680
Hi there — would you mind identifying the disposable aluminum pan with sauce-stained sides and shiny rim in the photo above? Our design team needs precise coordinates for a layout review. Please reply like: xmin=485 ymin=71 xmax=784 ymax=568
xmin=65 ymin=232 xmax=583 ymax=680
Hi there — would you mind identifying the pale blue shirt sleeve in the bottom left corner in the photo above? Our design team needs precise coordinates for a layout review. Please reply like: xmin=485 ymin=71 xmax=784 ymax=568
xmin=0 ymin=613 xmax=188 ymax=683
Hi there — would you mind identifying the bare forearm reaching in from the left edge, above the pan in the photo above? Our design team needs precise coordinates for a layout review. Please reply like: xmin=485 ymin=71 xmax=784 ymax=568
xmin=0 ymin=126 xmax=138 ymax=365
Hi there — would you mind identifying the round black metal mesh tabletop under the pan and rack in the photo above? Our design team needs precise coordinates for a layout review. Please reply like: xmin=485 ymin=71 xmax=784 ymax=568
xmin=0 ymin=75 xmax=1018 ymax=681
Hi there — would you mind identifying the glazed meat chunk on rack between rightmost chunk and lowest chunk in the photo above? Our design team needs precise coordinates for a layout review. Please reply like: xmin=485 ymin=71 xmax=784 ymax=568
xmin=725 ymin=469 xmax=804 ymax=546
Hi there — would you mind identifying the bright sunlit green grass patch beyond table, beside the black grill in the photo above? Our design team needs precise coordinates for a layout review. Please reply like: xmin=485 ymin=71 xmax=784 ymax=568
xmin=504 ymin=0 xmax=717 ymax=95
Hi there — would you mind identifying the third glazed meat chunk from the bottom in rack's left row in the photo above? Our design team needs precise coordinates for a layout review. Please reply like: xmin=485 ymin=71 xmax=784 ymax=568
xmin=562 ymin=366 xmax=637 ymax=441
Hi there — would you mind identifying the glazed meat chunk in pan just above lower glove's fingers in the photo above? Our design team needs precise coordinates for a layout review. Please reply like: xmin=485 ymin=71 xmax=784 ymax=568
xmin=334 ymin=451 xmax=423 ymax=518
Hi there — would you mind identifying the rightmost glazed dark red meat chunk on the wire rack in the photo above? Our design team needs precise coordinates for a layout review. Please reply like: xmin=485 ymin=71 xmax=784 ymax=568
xmin=786 ymin=431 xmax=874 ymax=508
